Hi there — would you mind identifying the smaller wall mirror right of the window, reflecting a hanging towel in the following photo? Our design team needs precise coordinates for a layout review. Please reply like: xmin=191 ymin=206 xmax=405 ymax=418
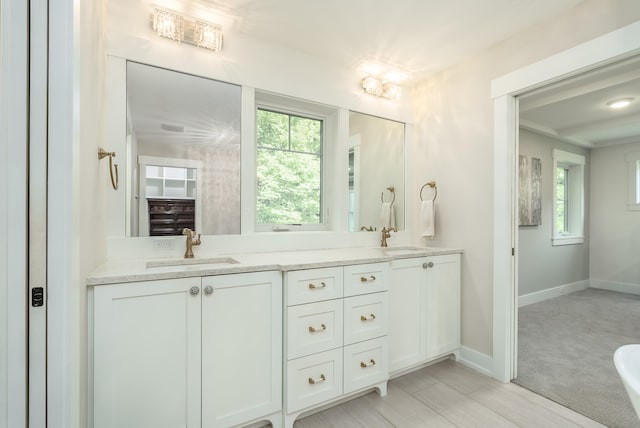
xmin=348 ymin=112 xmax=405 ymax=232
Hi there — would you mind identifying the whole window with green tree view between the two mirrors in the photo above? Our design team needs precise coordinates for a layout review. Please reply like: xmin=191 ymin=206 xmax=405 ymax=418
xmin=256 ymin=107 xmax=324 ymax=230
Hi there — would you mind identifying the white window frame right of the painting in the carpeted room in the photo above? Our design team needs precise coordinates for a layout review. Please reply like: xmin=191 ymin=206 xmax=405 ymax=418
xmin=552 ymin=149 xmax=586 ymax=246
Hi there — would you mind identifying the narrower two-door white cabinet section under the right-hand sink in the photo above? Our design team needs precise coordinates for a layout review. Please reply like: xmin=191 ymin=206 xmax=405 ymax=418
xmin=389 ymin=254 xmax=460 ymax=372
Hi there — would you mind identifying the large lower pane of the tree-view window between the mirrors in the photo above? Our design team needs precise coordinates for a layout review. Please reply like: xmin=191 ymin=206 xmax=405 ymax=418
xmin=257 ymin=149 xmax=322 ymax=224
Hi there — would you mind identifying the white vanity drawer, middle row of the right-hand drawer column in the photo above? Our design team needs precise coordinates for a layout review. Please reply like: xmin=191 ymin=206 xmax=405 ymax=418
xmin=344 ymin=291 xmax=389 ymax=345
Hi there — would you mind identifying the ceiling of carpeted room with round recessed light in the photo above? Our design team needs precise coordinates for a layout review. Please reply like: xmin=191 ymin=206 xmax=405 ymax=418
xmin=520 ymin=57 xmax=640 ymax=148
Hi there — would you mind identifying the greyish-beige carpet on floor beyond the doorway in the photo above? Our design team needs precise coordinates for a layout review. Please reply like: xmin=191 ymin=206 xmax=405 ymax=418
xmin=514 ymin=288 xmax=640 ymax=428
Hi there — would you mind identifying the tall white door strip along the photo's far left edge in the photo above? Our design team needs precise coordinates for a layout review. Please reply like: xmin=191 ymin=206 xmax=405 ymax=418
xmin=0 ymin=0 xmax=29 ymax=427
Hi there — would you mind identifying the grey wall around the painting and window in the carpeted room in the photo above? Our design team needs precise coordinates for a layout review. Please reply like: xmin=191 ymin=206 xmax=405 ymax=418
xmin=518 ymin=129 xmax=590 ymax=296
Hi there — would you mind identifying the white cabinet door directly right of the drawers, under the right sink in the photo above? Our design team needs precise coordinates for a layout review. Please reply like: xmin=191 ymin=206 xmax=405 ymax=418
xmin=389 ymin=258 xmax=426 ymax=372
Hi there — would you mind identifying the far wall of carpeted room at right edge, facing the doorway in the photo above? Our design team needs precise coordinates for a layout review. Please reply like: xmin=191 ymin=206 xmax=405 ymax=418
xmin=590 ymin=141 xmax=640 ymax=293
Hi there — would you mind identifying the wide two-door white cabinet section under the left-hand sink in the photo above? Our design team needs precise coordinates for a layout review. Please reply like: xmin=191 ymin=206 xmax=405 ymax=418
xmin=90 ymin=272 xmax=282 ymax=428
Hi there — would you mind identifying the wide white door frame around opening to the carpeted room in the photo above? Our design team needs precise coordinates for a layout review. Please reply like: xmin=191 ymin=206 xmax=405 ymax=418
xmin=491 ymin=21 xmax=640 ymax=382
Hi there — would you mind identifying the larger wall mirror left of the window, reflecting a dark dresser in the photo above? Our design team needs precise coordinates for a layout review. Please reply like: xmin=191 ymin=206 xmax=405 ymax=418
xmin=123 ymin=61 xmax=241 ymax=236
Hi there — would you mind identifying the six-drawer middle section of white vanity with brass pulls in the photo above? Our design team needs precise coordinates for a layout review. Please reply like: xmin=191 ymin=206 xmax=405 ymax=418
xmin=284 ymin=263 xmax=389 ymax=427
